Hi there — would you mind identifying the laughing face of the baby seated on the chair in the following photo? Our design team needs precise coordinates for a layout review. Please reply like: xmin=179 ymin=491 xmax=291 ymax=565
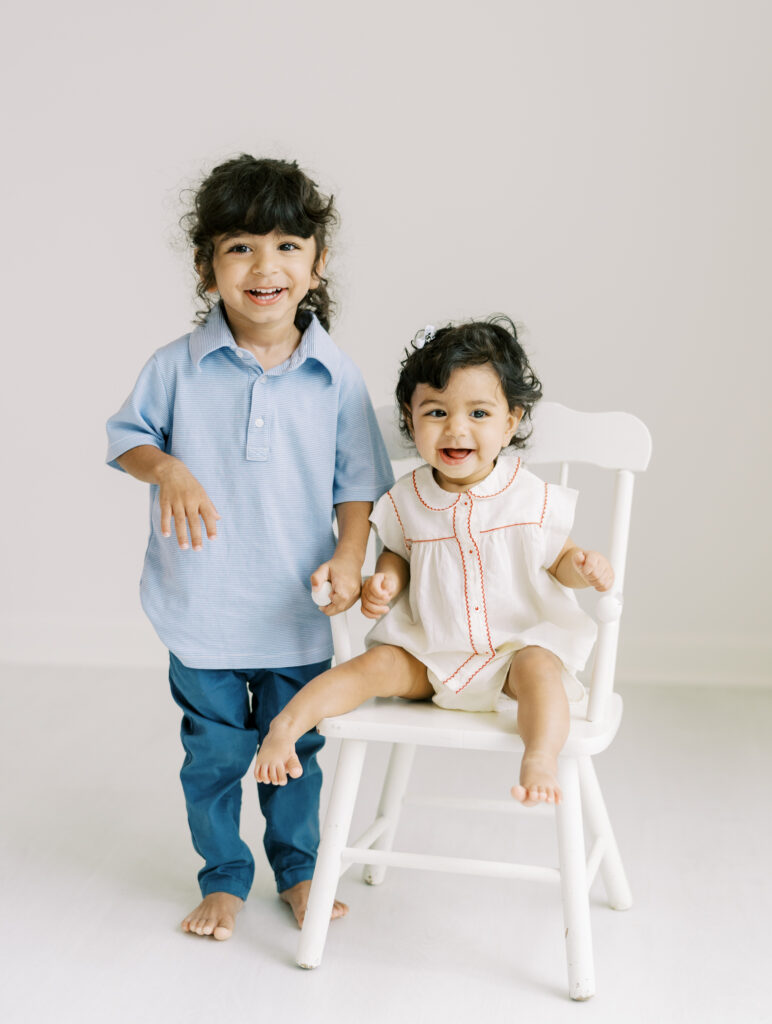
xmin=409 ymin=364 xmax=522 ymax=492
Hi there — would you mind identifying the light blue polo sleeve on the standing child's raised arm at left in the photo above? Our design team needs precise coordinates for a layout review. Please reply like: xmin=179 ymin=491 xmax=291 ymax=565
xmin=106 ymin=355 xmax=171 ymax=472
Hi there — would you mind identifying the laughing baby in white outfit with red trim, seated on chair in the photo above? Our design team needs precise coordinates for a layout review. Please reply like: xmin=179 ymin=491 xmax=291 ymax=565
xmin=255 ymin=317 xmax=613 ymax=806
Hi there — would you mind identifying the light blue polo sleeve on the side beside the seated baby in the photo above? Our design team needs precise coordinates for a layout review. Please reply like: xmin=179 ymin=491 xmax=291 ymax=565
xmin=333 ymin=360 xmax=394 ymax=505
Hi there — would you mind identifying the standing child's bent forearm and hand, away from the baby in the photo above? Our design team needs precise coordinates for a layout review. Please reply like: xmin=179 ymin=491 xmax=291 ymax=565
xmin=116 ymin=444 xmax=220 ymax=551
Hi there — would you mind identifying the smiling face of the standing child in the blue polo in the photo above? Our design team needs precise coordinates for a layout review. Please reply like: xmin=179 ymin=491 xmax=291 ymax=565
xmin=207 ymin=231 xmax=327 ymax=340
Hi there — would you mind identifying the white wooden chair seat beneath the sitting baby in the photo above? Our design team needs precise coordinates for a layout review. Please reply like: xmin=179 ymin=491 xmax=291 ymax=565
xmin=317 ymin=693 xmax=623 ymax=757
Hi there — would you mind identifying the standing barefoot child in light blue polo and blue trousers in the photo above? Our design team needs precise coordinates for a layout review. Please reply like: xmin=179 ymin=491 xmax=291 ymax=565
xmin=108 ymin=155 xmax=393 ymax=939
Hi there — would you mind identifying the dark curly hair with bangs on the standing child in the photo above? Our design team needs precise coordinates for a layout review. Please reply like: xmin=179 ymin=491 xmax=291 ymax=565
xmin=181 ymin=153 xmax=338 ymax=330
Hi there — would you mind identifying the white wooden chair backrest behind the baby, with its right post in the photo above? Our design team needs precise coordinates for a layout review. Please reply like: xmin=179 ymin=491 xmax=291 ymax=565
xmin=377 ymin=401 xmax=651 ymax=721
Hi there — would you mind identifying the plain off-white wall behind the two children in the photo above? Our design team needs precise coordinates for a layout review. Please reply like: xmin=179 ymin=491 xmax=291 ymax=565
xmin=0 ymin=0 xmax=772 ymax=683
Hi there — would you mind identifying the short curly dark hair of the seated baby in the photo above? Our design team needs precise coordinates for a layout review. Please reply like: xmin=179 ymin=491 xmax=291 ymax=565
xmin=396 ymin=314 xmax=542 ymax=449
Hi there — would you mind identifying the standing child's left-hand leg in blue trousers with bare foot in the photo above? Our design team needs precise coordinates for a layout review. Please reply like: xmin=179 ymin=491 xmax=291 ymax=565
xmin=169 ymin=654 xmax=257 ymax=938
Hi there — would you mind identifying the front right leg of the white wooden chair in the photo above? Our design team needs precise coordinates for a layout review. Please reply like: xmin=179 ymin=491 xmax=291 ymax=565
xmin=555 ymin=758 xmax=595 ymax=999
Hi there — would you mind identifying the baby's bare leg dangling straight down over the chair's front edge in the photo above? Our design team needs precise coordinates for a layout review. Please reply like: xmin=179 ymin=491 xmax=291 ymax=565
xmin=504 ymin=647 xmax=570 ymax=807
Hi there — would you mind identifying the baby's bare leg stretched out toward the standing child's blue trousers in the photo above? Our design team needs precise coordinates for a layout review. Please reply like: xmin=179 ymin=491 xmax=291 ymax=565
xmin=255 ymin=644 xmax=434 ymax=785
